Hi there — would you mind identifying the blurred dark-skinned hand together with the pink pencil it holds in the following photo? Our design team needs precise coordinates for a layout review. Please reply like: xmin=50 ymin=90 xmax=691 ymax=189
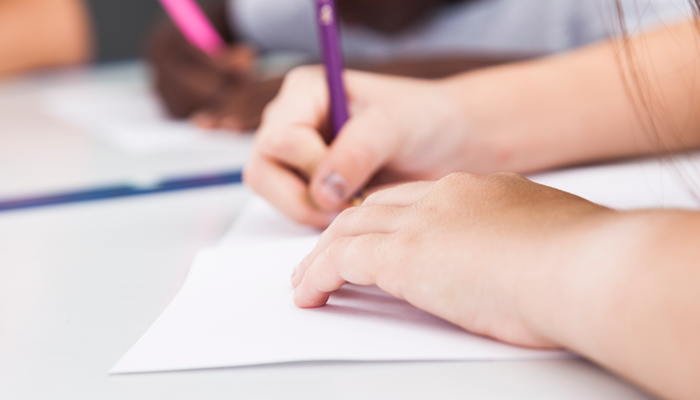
xmin=146 ymin=0 xmax=281 ymax=132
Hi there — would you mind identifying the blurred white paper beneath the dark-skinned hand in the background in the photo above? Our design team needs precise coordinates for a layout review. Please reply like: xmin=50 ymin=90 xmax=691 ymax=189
xmin=43 ymin=81 xmax=252 ymax=155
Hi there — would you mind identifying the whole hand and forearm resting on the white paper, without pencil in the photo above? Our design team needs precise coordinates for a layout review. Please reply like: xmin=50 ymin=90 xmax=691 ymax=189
xmin=292 ymin=173 xmax=700 ymax=400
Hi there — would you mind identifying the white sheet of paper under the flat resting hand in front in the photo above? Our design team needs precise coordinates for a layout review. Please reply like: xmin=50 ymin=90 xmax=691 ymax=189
xmin=111 ymin=155 xmax=698 ymax=373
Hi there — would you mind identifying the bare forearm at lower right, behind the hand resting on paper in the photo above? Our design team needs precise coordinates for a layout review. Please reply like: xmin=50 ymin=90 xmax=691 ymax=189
xmin=519 ymin=211 xmax=700 ymax=400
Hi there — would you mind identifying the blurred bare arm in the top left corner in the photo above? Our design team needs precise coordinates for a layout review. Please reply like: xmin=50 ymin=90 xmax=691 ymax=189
xmin=0 ymin=0 xmax=92 ymax=76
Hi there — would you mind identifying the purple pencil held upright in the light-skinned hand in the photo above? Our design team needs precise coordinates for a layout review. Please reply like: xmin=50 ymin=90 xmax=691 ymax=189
xmin=315 ymin=0 xmax=350 ymax=138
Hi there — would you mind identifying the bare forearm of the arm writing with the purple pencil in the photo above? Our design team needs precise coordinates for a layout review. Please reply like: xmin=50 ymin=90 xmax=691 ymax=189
xmin=445 ymin=19 xmax=700 ymax=173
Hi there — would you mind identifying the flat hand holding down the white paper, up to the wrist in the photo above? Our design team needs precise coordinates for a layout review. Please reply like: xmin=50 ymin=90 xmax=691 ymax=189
xmin=292 ymin=173 xmax=614 ymax=347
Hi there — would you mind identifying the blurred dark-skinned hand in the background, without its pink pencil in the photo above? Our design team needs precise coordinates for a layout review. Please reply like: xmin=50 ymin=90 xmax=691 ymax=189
xmin=147 ymin=21 xmax=272 ymax=130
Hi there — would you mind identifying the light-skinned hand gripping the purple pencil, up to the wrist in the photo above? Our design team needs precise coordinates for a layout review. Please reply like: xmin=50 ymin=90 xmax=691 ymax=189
xmin=245 ymin=67 xmax=468 ymax=228
